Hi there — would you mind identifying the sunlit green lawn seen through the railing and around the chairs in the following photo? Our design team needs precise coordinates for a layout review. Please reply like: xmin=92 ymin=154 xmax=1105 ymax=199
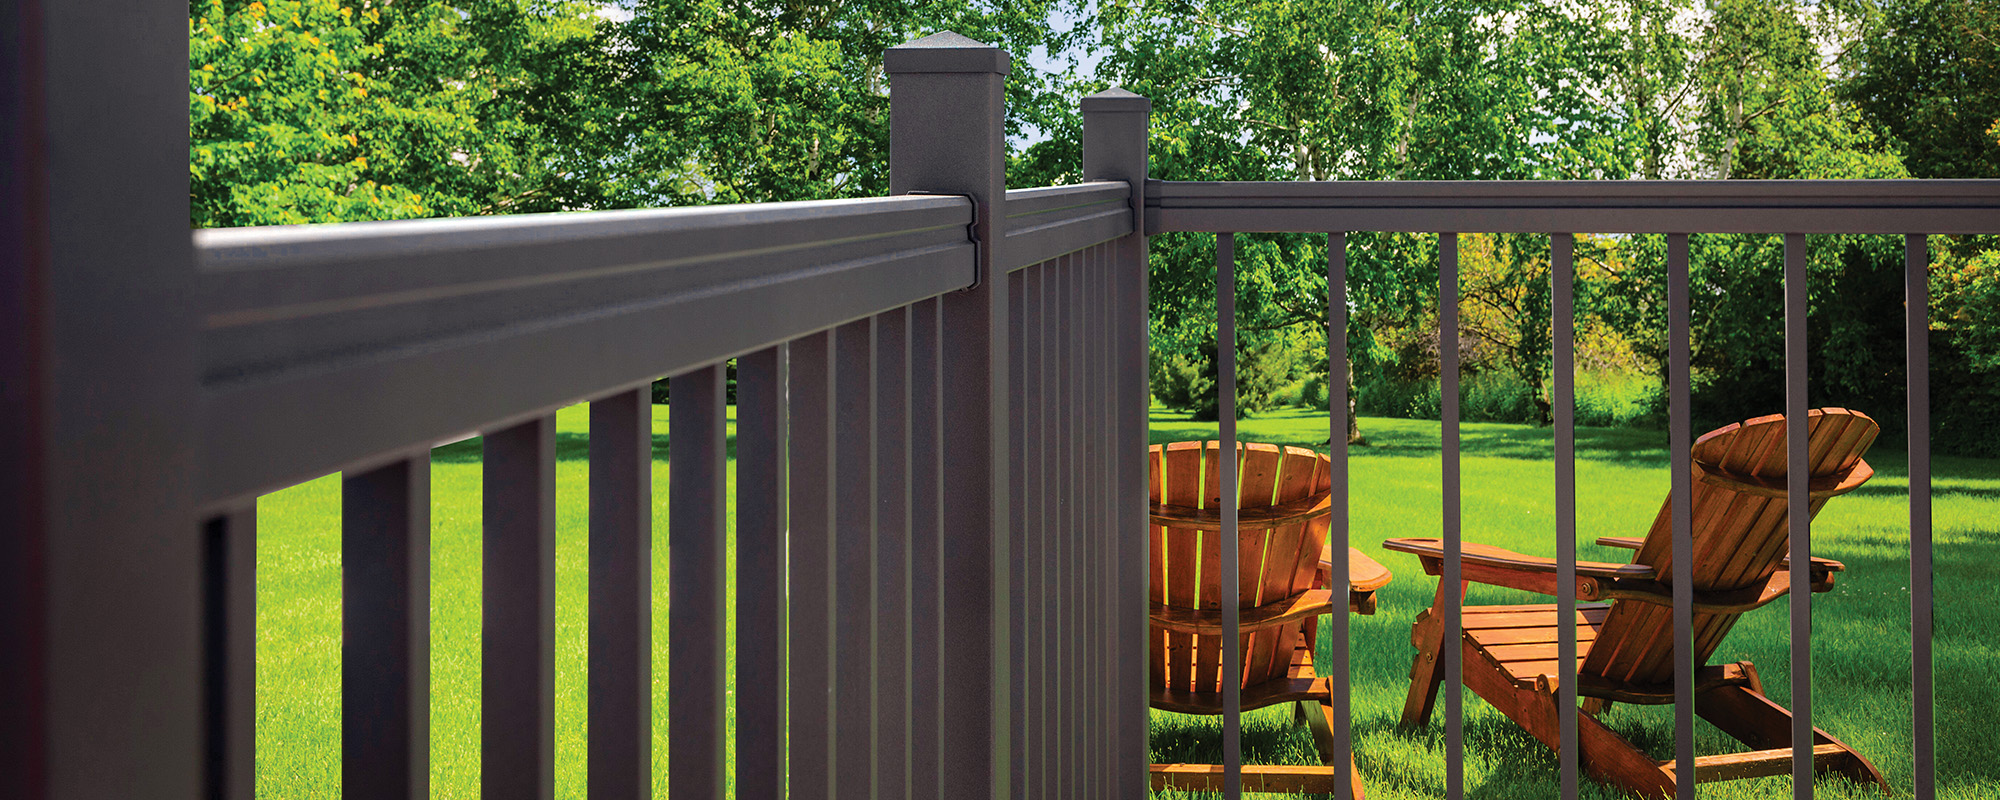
xmin=258 ymin=406 xmax=2000 ymax=800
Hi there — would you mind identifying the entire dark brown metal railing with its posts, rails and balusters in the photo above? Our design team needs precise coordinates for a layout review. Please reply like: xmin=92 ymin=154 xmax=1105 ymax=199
xmin=11 ymin=12 xmax=2000 ymax=798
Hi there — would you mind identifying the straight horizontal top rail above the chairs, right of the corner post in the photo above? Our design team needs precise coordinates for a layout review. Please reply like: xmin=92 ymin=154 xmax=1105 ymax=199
xmin=1146 ymin=180 xmax=2000 ymax=234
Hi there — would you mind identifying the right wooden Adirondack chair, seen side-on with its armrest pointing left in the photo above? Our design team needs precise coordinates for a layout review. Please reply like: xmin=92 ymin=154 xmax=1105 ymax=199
xmin=1382 ymin=408 xmax=1888 ymax=798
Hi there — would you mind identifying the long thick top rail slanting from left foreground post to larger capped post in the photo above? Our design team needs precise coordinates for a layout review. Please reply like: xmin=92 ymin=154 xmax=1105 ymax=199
xmin=194 ymin=196 xmax=976 ymax=504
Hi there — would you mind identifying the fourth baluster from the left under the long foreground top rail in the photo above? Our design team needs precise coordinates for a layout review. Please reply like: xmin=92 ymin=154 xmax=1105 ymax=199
xmin=588 ymin=386 xmax=652 ymax=800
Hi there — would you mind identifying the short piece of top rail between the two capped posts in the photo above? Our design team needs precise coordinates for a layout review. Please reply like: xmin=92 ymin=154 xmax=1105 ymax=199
xmin=1006 ymin=182 xmax=1136 ymax=270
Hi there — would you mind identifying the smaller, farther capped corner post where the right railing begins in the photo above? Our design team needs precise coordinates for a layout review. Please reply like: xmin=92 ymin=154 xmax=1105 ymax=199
xmin=1082 ymin=88 xmax=1152 ymax=798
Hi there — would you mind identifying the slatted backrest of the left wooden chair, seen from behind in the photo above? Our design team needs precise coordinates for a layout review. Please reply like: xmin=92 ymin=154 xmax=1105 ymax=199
xmin=1150 ymin=442 xmax=1346 ymax=708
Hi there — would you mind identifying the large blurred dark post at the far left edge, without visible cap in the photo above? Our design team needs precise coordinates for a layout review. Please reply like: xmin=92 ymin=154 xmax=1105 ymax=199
xmin=0 ymin=0 xmax=207 ymax=800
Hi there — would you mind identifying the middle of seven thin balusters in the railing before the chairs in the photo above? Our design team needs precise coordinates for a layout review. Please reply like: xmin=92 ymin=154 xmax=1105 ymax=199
xmin=1548 ymin=234 xmax=1578 ymax=800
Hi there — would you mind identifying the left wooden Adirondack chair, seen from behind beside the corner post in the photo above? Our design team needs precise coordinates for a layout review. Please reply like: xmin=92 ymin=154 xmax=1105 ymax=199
xmin=1148 ymin=442 xmax=1390 ymax=800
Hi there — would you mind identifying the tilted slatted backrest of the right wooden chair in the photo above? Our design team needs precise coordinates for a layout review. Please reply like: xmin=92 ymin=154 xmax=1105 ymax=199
xmin=1582 ymin=408 xmax=1880 ymax=684
